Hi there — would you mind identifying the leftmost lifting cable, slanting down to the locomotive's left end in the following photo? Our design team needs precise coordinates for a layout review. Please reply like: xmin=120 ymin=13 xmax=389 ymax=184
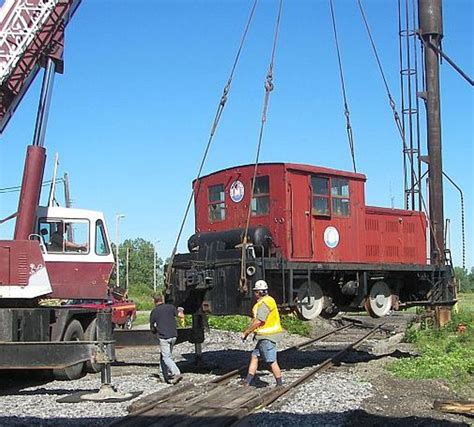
xmin=165 ymin=0 xmax=258 ymax=289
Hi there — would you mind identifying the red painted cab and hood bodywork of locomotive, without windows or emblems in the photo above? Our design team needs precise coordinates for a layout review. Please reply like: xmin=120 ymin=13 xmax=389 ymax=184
xmin=194 ymin=163 xmax=427 ymax=264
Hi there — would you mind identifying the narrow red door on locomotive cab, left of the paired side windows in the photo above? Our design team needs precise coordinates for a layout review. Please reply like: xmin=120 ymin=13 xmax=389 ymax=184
xmin=288 ymin=172 xmax=313 ymax=258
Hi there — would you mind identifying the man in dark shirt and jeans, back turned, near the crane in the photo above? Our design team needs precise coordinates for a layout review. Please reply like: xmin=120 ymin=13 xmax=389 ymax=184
xmin=150 ymin=295 xmax=184 ymax=384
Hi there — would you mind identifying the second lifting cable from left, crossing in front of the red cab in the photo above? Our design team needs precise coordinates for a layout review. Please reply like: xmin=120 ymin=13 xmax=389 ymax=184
xmin=239 ymin=0 xmax=283 ymax=293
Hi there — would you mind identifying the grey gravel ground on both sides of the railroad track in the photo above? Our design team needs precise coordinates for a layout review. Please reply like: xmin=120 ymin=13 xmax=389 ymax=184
xmin=0 ymin=322 xmax=472 ymax=427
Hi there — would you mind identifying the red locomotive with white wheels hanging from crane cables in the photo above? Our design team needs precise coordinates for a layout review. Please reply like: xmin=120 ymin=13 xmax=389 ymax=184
xmin=168 ymin=163 xmax=453 ymax=319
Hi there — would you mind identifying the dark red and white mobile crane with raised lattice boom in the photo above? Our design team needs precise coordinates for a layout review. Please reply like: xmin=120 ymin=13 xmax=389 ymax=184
xmin=0 ymin=0 xmax=121 ymax=389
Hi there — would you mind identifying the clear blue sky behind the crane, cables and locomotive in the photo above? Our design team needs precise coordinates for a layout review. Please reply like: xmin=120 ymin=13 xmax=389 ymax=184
xmin=0 ymin=0 xmax=474 ymax=268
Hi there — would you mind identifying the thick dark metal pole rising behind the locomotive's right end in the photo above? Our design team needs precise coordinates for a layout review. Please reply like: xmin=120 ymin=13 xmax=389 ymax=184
xmin=418 ymin=0 xmax=444 ymax=266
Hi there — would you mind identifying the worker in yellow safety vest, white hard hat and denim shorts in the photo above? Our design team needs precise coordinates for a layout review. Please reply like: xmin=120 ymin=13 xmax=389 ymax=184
xmin=242 ymin=280 xmax=283 ymax=387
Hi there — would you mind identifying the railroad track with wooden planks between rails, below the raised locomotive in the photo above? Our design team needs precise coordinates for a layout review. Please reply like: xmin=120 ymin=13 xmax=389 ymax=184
xmin=111 ymin=323 xmax=383 ymax=427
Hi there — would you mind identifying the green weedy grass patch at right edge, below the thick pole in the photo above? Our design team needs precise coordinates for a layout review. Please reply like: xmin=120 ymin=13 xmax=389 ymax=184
xmin=387 ymin=294 xmax=474 ymax=397
